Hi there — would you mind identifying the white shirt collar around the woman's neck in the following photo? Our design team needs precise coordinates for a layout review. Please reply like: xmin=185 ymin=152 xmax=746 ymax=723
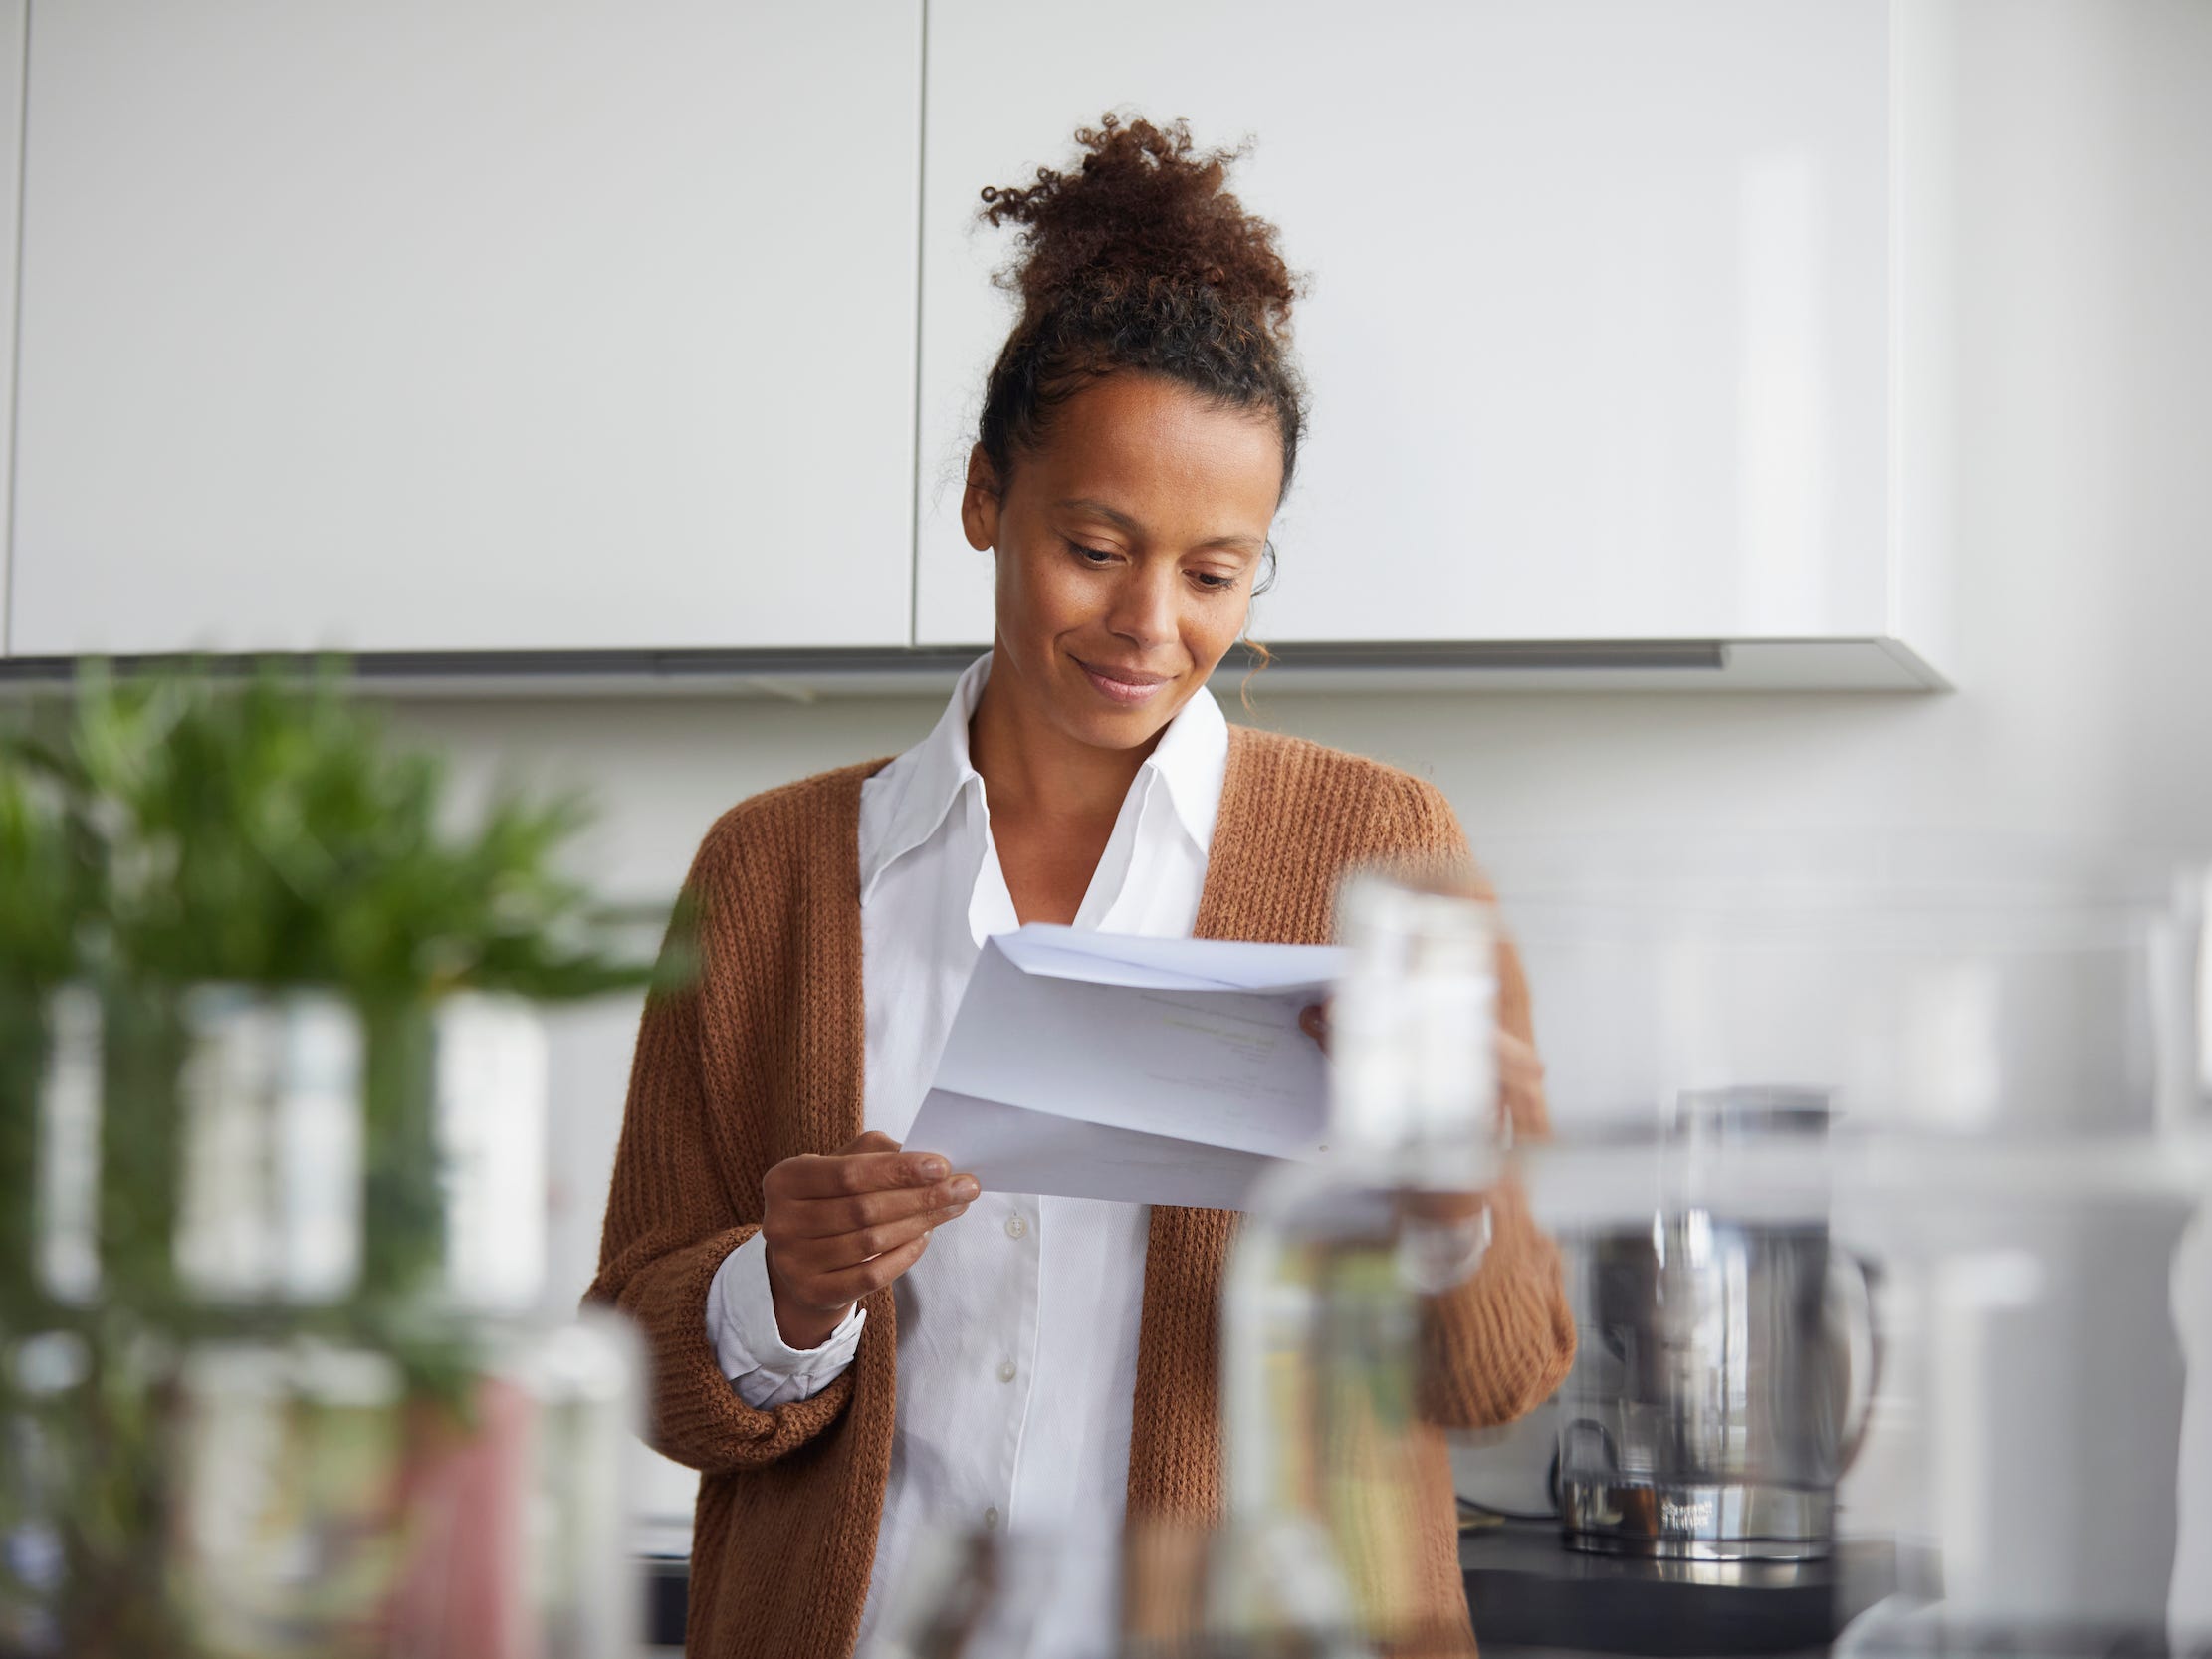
xmin=860 ymin=652 xmax=1229 ymax=898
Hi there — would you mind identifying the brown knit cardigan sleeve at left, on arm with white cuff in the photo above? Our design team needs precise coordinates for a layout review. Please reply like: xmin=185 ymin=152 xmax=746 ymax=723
xmin=584 ymin=833 xmax=865 ymax=1476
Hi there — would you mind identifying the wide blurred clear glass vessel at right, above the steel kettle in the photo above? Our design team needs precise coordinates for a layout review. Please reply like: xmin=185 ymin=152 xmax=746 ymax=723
xmin=1486 ymin=831 xmax=2212 ymax=1137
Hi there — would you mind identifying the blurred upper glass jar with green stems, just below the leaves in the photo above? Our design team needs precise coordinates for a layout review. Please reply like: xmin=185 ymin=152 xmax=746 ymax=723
xmin=11 ymin=984 xmax=547 ymax=1313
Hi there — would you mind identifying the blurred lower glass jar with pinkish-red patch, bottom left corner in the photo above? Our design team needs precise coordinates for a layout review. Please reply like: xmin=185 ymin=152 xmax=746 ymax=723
xmin=157 ymin=1320 xmax=639 ymax=1659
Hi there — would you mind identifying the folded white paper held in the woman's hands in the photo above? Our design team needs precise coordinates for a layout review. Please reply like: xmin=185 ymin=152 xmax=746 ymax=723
xmin=905 ymin=922 xmax=1343 ymax=1208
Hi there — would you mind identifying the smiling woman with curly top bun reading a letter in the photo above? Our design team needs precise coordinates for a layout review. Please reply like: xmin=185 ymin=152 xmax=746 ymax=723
xmin=590 ymin=118 xmax=1573 ymax=1659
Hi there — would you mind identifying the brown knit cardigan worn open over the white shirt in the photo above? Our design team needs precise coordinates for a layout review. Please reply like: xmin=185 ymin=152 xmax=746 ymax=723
xmin=586 ymin=726 xmax=1575 ymax=1659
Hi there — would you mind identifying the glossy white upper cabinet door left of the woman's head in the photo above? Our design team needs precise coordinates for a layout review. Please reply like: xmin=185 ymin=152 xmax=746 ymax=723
xmin=13 ymin=0 xmax=920 ymax=655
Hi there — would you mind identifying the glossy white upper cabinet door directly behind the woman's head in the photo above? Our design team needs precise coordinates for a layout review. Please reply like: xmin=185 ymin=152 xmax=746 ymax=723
xmin=918 ymin=0 xmax=1889 ymax=643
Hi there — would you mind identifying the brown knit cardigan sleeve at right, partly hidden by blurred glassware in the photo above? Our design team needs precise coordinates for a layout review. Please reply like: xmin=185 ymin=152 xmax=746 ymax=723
xmin=1407 ymin=779 xmax=1575 ymax=1429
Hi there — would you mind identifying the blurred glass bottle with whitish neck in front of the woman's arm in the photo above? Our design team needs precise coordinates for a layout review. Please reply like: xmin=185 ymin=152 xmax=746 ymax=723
xmin=1206 ymin=873 xmax=1500 ymax=1659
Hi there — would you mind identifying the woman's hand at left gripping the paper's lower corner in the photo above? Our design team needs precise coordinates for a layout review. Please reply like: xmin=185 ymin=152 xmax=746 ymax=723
xmin=761 ymin=1130 xmax=983 ymax=1349
